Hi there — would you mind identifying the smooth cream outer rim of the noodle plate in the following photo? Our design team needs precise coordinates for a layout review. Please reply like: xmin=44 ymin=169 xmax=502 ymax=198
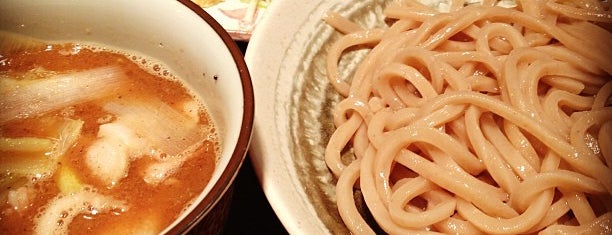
xmin=245 ymin=0 xmax=340 ymax=234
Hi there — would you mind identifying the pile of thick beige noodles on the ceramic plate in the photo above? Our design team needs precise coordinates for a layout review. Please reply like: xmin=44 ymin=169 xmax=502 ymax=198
xmin=325 ymin=0 xmax=612 ymax=234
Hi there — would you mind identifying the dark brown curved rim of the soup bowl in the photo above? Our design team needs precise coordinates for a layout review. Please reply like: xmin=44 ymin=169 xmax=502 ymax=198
xmin=166 ymin=0 xmax=255 ymax=234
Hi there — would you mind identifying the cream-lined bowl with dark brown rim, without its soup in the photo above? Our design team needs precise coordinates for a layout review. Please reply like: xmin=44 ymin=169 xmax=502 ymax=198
xmin=0 ymin=0 xmax=254 ymax=234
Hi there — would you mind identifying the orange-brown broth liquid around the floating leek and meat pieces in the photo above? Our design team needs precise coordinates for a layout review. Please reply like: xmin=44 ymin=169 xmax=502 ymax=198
xmin=0 ymin=41 xmax=219 ymax=234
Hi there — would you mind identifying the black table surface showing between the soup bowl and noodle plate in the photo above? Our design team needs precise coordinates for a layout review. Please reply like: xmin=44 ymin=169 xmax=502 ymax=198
xmin=223 ymin=39 xmax=287 ymax=234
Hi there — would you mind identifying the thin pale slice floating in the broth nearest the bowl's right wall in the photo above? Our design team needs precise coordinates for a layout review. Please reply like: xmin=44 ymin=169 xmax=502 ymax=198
xmin=104 ymin=97 xmax=205 ymax=184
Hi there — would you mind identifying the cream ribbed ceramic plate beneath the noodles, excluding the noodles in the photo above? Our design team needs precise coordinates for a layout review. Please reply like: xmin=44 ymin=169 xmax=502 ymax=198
xmin=246 ymin=0 xmax=387 ymax=234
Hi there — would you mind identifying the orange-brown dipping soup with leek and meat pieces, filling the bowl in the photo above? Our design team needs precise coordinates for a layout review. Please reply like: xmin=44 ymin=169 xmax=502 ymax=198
xmin=0 ymin=35 xmax=220 ymax=234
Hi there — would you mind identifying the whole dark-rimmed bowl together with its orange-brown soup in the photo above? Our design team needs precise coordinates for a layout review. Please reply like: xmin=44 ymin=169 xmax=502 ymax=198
xmin=0 ymin=0 xmax=254 ymax=234
